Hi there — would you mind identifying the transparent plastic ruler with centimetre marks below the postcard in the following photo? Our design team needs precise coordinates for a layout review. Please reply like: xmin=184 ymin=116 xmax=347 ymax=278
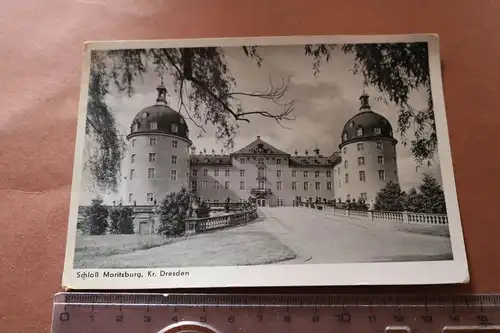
xmin=52 ymin=292 xmax=500 ymax=333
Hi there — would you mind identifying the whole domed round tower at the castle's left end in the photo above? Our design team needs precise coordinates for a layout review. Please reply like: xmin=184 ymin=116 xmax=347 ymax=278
xmin=124 ymin=82 xmax=191 ymax=205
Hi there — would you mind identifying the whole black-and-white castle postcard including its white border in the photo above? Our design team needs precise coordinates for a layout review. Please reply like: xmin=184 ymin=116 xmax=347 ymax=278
xmin=63 ymin=35 xmax=469 ymax=289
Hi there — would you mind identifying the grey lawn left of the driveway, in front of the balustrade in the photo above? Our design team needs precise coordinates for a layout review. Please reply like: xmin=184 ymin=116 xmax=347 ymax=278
xmin=75 ymin=224 xmax=296 ymax=268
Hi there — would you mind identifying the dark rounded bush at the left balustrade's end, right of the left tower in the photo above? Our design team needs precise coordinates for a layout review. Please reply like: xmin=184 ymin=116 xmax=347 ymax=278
xmin=158 ymin=187 xmax=192 ymax=237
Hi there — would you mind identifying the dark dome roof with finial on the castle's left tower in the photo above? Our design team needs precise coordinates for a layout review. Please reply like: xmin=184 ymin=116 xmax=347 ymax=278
xmin=127 ymin=83 xmax=189 ymax=140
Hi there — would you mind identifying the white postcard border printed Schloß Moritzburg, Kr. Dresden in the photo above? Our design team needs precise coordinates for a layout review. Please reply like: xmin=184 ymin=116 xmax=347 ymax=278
xmin=62 ymin=34 xmax=469 ymax=290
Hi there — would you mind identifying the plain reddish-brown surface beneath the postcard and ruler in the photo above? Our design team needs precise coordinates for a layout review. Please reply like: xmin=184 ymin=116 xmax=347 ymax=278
xmin=0 ymin=0 xmax=500 ymax=332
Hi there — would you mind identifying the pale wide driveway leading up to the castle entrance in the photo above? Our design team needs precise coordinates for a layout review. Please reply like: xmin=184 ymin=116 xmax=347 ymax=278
xmin=260 ymin=207 xmax=452 ymax=264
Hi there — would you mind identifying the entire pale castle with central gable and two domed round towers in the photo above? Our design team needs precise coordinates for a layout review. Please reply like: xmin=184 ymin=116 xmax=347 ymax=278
xmin=123 ymin=84 xmax=398 ymax=206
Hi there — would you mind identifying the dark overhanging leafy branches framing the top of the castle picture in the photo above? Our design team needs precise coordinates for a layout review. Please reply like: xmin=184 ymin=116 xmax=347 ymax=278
xmin=86 ymin=43 xmax=437 ymax=191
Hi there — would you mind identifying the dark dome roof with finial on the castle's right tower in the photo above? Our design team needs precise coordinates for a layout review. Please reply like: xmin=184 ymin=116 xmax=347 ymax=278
xmin=339 ymin=93 xmax=396 ymax=147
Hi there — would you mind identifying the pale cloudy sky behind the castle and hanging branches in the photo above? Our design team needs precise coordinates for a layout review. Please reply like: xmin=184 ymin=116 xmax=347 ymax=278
xmin=80 ymin=46 xmax=441 ymax=204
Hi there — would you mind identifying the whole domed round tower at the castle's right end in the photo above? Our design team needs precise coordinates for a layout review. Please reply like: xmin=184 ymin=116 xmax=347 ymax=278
xmin=334 ymin=93 xmax=398 ymax=203
